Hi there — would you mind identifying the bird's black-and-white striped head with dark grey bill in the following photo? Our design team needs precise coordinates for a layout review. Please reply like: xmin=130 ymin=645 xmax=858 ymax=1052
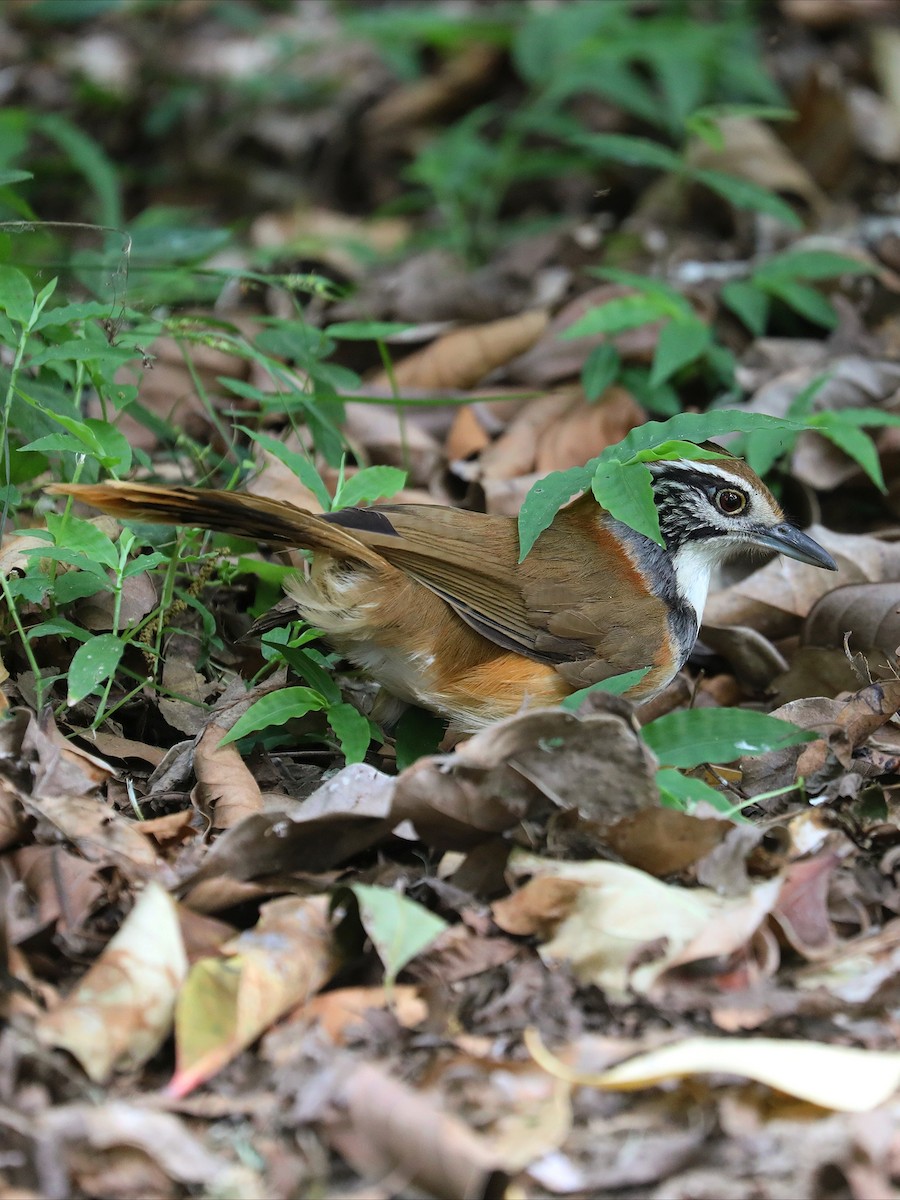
xmin=648 ymin=446 xmax=838 ymax=572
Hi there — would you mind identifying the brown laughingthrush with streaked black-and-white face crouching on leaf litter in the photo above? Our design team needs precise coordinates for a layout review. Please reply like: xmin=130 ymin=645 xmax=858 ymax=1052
xmin=49 ymin=457 xmax=836 ymax=732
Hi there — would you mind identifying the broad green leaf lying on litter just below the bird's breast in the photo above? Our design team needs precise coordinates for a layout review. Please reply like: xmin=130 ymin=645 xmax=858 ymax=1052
xmin=641 ymin=708 xmax=818 ymax=767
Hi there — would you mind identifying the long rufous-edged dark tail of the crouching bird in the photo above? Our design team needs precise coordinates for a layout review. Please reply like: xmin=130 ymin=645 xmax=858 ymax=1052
xmin=47 ymin=481 xmax=386 ymax=568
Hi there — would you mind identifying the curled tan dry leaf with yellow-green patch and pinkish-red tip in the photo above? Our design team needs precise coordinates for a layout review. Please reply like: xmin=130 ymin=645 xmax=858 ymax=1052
xmin=169 ymin=896 xmax=337 ymax=1096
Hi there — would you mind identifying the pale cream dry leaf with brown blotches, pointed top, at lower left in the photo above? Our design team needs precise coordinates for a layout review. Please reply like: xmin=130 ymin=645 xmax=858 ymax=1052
xmin=36 ymin=883 xmax=187 ymax=1082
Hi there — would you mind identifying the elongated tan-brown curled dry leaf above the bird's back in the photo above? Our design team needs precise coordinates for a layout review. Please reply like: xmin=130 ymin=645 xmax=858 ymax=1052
xmin=372 ymin=308 xmax=548 ymax=391
